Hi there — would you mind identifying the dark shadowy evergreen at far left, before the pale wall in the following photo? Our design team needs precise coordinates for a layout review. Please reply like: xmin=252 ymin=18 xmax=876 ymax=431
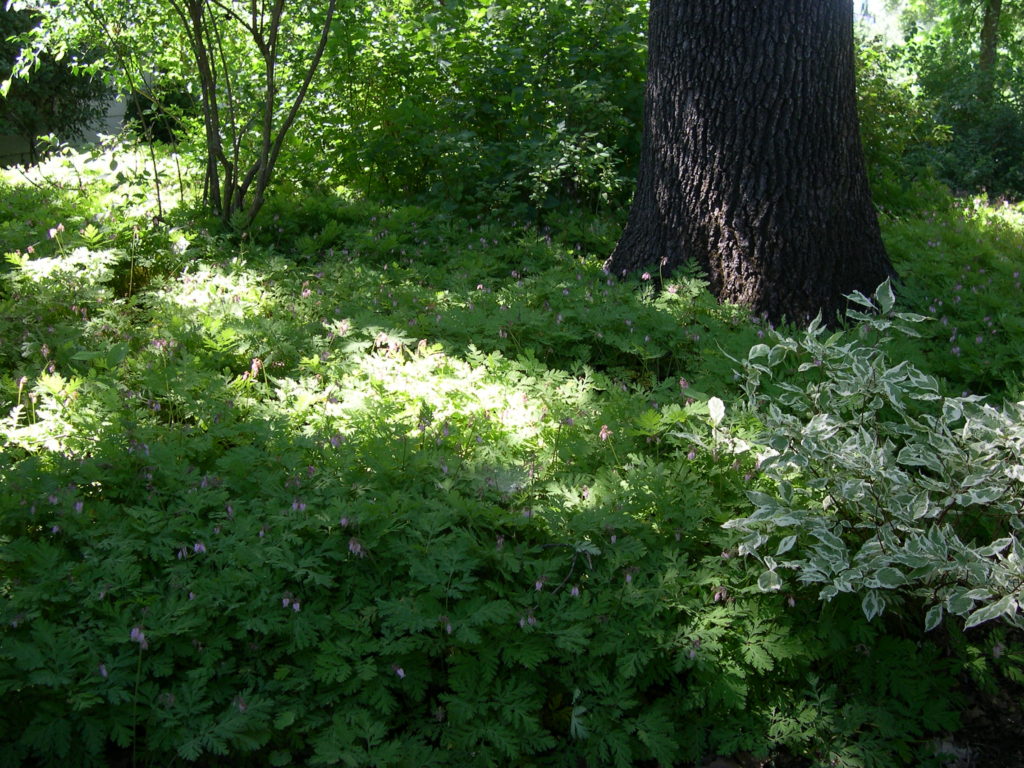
xmin=0 ymin=5 xmax=110 ymax=164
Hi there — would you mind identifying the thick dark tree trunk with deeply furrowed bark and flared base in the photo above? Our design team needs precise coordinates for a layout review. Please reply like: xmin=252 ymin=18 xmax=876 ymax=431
xmin=606 ymin=0 xmax=893 ymax=323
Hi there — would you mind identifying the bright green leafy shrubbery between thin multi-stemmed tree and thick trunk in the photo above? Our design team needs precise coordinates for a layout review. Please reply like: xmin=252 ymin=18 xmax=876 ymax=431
xmin=295 ymin=0 xmax=646 ymax=216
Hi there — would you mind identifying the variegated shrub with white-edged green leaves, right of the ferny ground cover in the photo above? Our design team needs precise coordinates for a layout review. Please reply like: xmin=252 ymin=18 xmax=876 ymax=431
xmin=727 ymin=284 xmax=1024 ymax=630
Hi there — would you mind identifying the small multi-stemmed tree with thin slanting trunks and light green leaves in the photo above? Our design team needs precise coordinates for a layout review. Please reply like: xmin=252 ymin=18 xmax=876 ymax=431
xmin=8 ymin=0 xmax=336 ymax=229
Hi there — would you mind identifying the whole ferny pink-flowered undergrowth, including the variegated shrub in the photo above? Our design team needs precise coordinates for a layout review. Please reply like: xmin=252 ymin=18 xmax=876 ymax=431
xmin=0 ymin=147 xmax=1024 ymax=766
